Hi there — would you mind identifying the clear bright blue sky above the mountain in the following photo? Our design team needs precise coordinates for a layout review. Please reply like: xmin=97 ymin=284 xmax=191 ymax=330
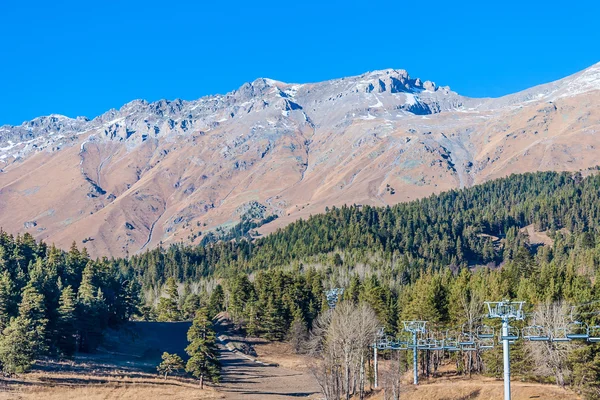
xmin=0 ymin=0 xmax=600 ymax=125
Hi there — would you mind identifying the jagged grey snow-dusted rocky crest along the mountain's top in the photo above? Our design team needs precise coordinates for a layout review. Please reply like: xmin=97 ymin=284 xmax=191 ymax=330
xmin=0 ymin=70 xmax=462 ymax=162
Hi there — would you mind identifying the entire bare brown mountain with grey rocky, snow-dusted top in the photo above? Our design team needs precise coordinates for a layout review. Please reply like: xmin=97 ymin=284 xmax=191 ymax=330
xmin=0 ymin=63 xmax=600 ymax=256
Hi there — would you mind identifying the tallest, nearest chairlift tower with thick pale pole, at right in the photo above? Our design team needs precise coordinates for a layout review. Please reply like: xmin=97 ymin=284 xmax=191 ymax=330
xmin=485 ymin=300 xmax=525 ymax=400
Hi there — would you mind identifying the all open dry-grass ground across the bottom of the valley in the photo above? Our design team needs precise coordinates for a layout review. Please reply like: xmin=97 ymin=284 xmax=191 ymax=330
xmin=0 ymin=319 xmax=580 ymax=400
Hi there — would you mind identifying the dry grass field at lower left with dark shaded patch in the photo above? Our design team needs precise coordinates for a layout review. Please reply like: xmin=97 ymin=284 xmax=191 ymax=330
xmin=0 ymin=322 xmax=221 ymax=400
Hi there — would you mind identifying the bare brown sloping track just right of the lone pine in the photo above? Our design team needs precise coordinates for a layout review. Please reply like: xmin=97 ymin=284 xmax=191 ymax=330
xmin=215 ymin=318 xmax=323 ymax=400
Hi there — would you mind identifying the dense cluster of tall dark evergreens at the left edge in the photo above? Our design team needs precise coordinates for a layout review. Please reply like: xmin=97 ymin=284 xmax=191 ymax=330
xmin=0 ymin=230 xmax=140 ymax=373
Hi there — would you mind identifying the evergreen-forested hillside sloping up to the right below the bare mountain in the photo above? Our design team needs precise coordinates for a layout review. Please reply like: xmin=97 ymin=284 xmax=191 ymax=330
xmin=115 ymin=172 xmax=600 ymax=288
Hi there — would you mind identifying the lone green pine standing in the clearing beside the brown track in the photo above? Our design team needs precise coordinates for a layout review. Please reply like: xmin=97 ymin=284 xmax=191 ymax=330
xmin=185 ymin=308 xmax=221 ymax=389
